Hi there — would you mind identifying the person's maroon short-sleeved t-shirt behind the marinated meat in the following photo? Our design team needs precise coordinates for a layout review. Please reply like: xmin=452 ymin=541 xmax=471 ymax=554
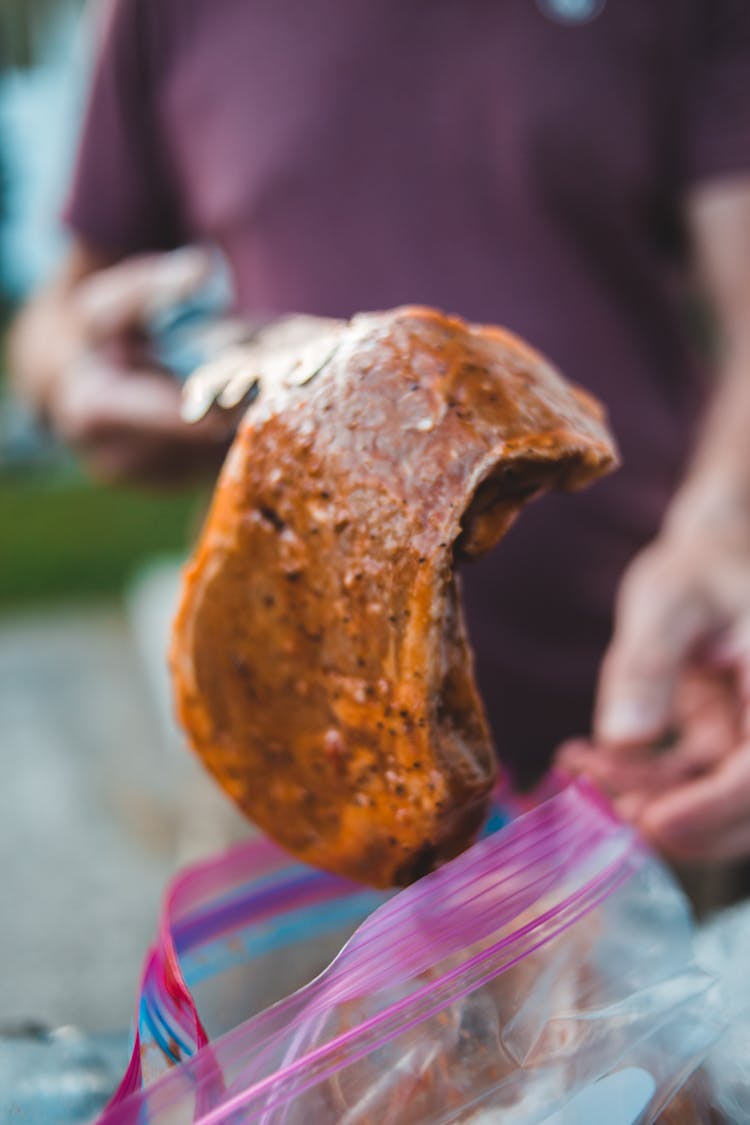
xmin=66 ymin=0 xmax=750 ymax=780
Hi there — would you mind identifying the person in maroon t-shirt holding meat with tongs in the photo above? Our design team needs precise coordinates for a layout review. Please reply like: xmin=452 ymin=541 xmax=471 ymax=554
xmin=10 ymin=0 xmax=750 ymax=860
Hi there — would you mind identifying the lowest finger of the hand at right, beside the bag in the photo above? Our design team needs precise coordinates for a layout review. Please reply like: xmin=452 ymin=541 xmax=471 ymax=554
xmin=641 ymin=746 xmax=750 ymax=858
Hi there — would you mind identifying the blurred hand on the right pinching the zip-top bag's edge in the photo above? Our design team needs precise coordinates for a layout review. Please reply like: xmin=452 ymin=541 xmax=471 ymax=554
xmin=558 ymin=519 xmax=750 ymax=862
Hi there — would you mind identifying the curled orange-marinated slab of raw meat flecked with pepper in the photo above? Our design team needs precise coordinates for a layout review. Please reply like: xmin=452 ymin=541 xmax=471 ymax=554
xmin=171 ymin=307 xmax=616 ymax=887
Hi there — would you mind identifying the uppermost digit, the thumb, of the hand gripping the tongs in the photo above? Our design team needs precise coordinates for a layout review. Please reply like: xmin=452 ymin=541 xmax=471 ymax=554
xmin=75 ymin=246 xmax=214 ymax=341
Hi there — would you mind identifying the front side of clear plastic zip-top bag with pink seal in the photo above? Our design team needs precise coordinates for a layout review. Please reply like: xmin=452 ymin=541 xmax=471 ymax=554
xmin=101 ymin=785 xmax=721 ymax=1125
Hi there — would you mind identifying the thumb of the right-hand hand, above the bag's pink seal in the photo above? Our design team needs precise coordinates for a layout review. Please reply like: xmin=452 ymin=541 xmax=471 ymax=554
xmin=594 ymin=547 xmax=712 ymax=747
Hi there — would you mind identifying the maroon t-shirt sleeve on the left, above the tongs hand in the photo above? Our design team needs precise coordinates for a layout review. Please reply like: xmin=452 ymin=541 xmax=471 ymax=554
xmin=63 ymin=0 xmax=182 ymax=254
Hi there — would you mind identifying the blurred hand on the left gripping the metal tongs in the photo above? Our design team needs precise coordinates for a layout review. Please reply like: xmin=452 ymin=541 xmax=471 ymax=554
xmin=44 ymin=248 xmax=234 ymax=484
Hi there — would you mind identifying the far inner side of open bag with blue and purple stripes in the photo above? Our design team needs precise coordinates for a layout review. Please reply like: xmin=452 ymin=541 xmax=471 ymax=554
xmin=117 ymin=838 xmax=386 ymax=1099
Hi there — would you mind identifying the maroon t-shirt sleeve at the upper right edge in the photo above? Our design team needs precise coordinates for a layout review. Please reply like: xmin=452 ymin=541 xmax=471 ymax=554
xmin=686 ymin=0 xmax=750 ymax=181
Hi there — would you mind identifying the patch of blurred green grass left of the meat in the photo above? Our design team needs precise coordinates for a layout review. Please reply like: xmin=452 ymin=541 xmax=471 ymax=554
xmin=0 ymin=465 xmax=205 ymax=609
